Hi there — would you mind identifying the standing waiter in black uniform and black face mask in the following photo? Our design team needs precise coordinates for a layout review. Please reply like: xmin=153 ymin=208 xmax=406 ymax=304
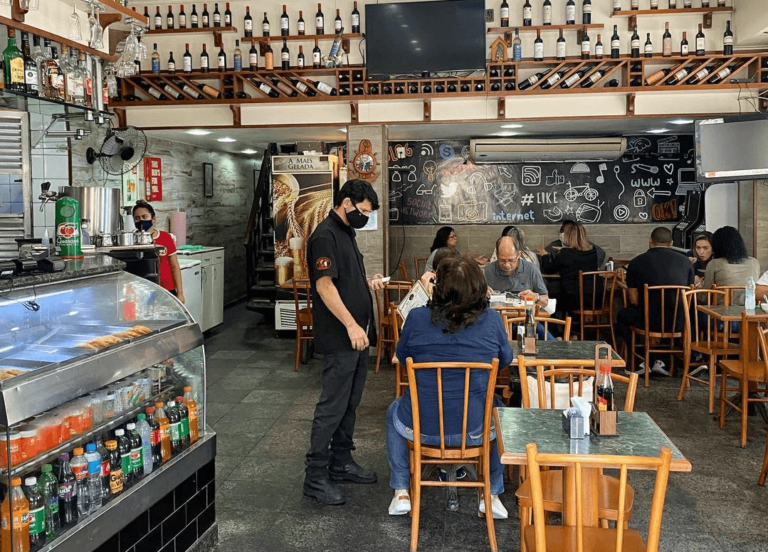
xmin=304 ymin=180 xmax=384 ymax=504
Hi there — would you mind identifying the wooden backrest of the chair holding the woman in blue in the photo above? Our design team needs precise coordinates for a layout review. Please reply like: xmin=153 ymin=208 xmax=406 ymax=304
xmin=405 ymin=357 xmax=499 ymax=459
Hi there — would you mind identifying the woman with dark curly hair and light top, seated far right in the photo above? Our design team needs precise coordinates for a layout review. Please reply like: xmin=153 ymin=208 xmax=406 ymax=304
xmin=701 ymin=226 xmax=760 ymax=305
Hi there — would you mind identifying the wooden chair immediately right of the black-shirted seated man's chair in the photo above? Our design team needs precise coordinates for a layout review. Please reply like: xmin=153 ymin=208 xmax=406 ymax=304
xmin=677 ymin=289 xmax=739 ymax=414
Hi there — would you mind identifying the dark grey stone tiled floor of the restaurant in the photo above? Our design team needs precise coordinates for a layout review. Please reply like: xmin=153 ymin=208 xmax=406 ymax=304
xmin=206 ymin=305 xmax=768 ymax=552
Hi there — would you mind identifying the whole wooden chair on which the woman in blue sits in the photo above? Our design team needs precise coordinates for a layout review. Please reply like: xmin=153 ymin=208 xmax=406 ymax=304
xmin=406 ymin=357 xmax=499 ymax=552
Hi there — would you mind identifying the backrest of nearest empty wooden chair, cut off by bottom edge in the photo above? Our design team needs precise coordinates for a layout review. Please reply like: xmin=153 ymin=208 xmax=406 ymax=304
xmin=526 ymin=443 xmax=672 ymax=552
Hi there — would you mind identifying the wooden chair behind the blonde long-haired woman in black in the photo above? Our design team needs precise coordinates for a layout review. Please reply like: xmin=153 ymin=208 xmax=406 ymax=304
xmin=574 ymin=270 xmax=616 ymax=348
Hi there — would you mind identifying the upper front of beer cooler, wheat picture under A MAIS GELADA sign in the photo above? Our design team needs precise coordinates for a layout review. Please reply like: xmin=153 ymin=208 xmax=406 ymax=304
xmin=272 ymin=155 xmax=337 ymax=285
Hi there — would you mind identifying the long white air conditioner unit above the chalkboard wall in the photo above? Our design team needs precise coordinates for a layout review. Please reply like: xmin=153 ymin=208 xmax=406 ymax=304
xmin=469 ymin=138 xmax=627 ymax=165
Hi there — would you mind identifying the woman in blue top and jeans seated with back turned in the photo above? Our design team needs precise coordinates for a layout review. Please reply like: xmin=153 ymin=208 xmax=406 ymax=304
xmin=387 ymin=256 xmax=513 ymax=519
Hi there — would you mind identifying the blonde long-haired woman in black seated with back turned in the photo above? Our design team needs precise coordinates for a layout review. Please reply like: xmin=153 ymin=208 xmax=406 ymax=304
xmin=541 ymin=222 xmax=599 ymax=312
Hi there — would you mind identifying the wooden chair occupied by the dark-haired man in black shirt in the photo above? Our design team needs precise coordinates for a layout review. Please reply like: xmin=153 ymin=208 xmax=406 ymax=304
xmin=629 ymin=284 xmax=691 ymax=387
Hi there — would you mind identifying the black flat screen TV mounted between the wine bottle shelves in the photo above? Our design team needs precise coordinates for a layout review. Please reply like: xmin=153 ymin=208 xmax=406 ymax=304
xmin=365 ymin=0 xmax=486 ymax=80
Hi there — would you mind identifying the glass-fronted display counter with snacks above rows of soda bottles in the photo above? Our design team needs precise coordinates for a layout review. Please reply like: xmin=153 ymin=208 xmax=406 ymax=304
xmin=0 ymin=254 xmax=217 ymax=552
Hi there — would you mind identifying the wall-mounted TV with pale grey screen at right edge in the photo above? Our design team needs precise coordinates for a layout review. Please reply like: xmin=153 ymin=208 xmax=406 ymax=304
xmin=695 ymin=115 xmax=768 ymax=182
